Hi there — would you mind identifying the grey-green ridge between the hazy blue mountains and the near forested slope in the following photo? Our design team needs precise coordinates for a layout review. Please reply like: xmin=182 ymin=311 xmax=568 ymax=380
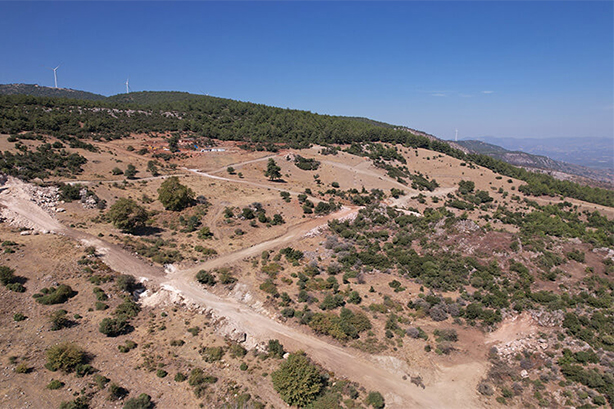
xmin=456 ymin=140 xmax=614 ymax=186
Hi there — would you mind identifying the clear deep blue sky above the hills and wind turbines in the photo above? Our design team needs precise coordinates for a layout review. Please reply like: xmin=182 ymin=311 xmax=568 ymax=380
xmin=0 ymin=1 xmax=614 ymax=138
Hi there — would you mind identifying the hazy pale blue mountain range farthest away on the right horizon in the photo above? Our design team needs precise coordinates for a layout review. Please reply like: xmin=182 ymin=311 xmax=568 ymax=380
xmin=475 ymin=136 xmax=614 ymax=170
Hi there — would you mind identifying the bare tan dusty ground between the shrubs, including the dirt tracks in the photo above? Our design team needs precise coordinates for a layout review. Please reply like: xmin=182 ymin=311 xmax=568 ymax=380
xmin=0 ymin=135 xmax=613 ymax=408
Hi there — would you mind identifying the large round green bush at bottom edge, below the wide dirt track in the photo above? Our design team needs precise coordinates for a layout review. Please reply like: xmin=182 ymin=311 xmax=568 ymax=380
xmin=271 ymin=352 xmax=324 ymax=407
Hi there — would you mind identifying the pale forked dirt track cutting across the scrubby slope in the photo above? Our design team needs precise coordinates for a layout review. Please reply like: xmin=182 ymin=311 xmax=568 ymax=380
xmin=0 ymin=175 xmax=485 ymax=408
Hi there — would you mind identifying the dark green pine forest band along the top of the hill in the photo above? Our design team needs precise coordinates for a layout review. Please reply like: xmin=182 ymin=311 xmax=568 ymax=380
xmin=0 ymin=92 xmax=614 ymax=206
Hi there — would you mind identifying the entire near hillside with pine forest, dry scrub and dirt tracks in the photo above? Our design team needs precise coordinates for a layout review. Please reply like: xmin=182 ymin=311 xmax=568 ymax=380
xmin=0 ymin=93 xmax=614 ymax=409
